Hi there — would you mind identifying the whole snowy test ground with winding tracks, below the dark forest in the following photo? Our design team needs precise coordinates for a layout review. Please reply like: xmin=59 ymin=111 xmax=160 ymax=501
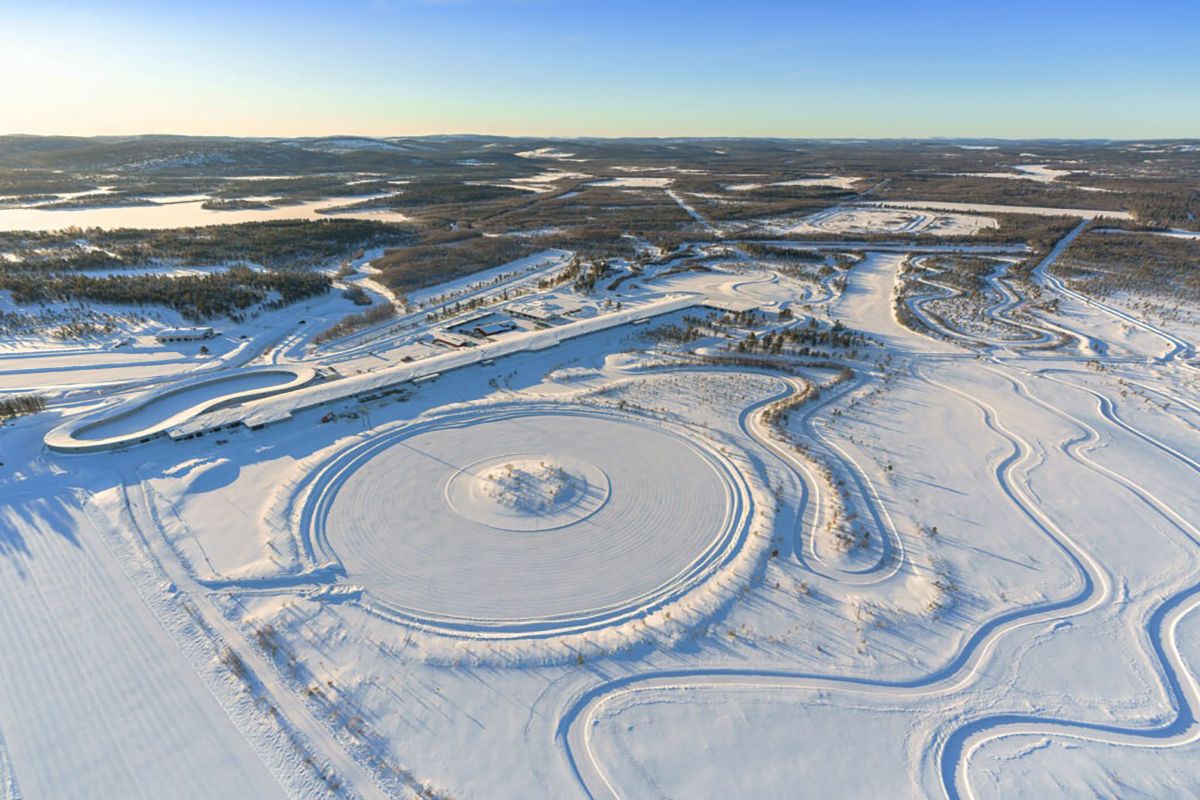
xmin=0 ymin=195 xmax=1200 ymax=800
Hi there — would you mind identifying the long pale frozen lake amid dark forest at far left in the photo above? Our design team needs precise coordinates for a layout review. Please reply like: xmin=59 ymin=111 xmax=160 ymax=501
xmin=0 ymin=196 xmax=407 ymax=230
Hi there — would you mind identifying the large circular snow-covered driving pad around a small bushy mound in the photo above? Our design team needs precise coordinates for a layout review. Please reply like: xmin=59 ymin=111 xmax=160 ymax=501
xmin=295 ymin=403 xmax=755 ymax=639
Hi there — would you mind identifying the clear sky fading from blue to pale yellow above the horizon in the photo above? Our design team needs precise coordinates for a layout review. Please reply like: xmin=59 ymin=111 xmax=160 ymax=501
xmin=0 ymin=0 xmax=1200 ymax=138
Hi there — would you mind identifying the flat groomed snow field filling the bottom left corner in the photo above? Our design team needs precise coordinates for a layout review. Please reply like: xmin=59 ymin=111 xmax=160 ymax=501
xmin=0 ymin=491 xmax=286 ymax=798
